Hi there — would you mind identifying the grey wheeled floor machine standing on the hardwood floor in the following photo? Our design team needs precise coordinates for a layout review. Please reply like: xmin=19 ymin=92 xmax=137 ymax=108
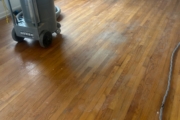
xmin=6 ymin=0 xmax=61 ymax=47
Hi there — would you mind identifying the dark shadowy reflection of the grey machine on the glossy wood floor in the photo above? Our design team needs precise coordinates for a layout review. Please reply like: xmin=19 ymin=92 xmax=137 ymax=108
xmin=15 ymin=35 xmax=74 ymax=81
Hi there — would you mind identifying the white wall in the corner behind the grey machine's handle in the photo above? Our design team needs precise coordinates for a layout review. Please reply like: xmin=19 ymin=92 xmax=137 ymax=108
xmin=0 ymin=0 xmax=20 ymax=19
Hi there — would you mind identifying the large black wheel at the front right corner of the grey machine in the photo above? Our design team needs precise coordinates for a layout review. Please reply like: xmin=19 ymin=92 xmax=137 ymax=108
xmin=39 ymin=31 xmax=52 ymax=48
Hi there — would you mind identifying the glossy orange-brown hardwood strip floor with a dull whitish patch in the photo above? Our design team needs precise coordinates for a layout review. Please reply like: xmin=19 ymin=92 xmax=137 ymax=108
xmin=0 ymin=0 xmax=180 ymax=120
